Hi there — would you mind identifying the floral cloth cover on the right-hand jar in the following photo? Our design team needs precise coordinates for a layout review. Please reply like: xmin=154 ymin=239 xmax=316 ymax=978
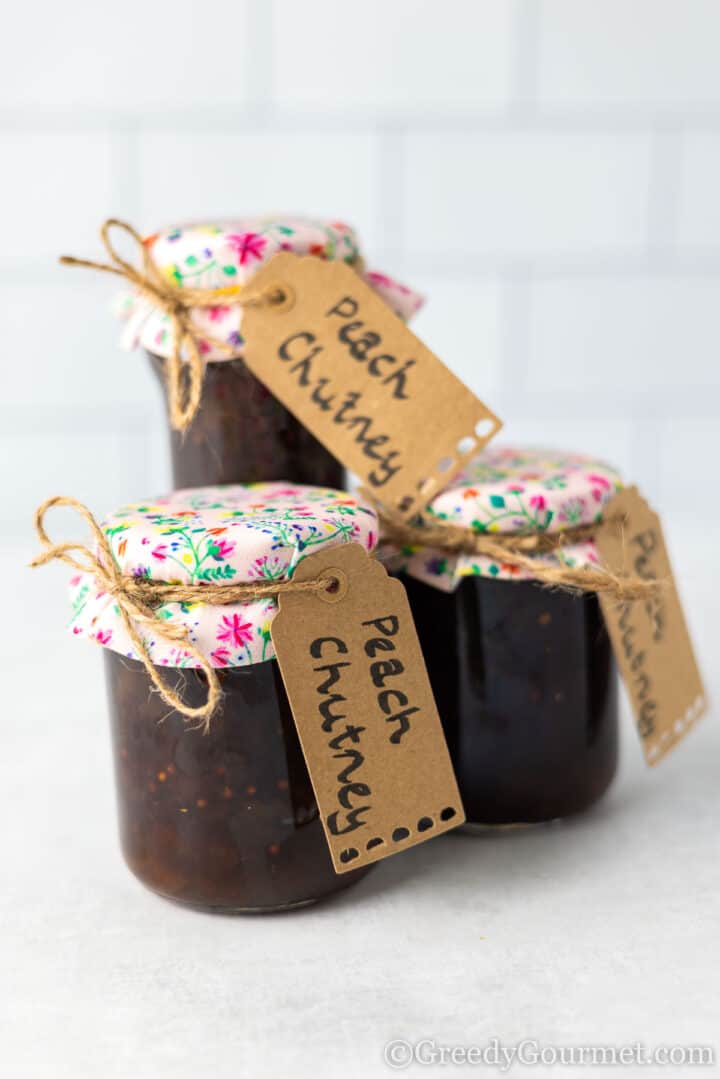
xmin=392 ymin=445 xmax=623 ymax=591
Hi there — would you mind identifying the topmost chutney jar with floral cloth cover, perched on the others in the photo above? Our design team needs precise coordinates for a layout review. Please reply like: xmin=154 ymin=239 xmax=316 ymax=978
xmin=120 ymin=217 xmax=422 ymax=488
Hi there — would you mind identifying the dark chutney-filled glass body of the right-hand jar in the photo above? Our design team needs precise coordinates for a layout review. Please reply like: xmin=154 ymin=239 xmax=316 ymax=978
xmin=403 ymin=576 xmax=619 ymax=829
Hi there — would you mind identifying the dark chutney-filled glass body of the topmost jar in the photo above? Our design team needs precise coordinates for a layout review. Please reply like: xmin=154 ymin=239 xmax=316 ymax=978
xmin=147 ymin=353 xmax=344 ymax=488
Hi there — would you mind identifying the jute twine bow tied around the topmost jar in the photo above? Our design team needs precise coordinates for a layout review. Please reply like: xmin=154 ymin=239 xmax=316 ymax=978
xmin=60 ymin=218 xmax=285 ymax=432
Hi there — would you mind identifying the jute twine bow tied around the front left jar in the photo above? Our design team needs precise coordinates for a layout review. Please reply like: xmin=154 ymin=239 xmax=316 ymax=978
xmin=30 ymin=495 xmax=336 ymax=733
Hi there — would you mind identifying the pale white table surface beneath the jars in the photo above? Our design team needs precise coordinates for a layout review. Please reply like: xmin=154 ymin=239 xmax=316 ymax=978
xmin=0 ymin=530 xmax=720 ymax=1079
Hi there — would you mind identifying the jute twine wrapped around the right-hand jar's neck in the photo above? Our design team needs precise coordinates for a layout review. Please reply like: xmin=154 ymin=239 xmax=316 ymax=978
xmin=375 ymin=492 xmax=664 ymax=601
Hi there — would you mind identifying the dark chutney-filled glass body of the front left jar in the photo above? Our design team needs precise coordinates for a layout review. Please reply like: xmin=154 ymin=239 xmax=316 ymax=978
xmin=104 ymin=650 xmax=367 ymax=913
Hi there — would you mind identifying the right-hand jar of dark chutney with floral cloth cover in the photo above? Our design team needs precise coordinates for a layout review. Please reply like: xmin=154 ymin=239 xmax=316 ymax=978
xmin=388 ymin=447 xmax=620 ymax=830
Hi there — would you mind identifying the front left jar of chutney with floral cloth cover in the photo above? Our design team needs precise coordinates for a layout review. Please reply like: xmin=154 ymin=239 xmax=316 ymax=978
xmin=59 ymin=482 xmax=377 ymax=913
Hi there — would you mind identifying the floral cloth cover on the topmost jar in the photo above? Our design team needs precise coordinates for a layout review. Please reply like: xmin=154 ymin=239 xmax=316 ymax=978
xmin=118 ymin=216 xmax=423 ymax=361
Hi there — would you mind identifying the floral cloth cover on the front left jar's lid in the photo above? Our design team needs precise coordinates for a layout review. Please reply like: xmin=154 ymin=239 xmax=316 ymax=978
xmin=70 ymin=482 xmax=378 ymax=667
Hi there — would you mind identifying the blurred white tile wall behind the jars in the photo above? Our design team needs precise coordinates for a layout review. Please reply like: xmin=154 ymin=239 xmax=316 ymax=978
xmin=0 ymin=0 xmax=720 ymax=537
